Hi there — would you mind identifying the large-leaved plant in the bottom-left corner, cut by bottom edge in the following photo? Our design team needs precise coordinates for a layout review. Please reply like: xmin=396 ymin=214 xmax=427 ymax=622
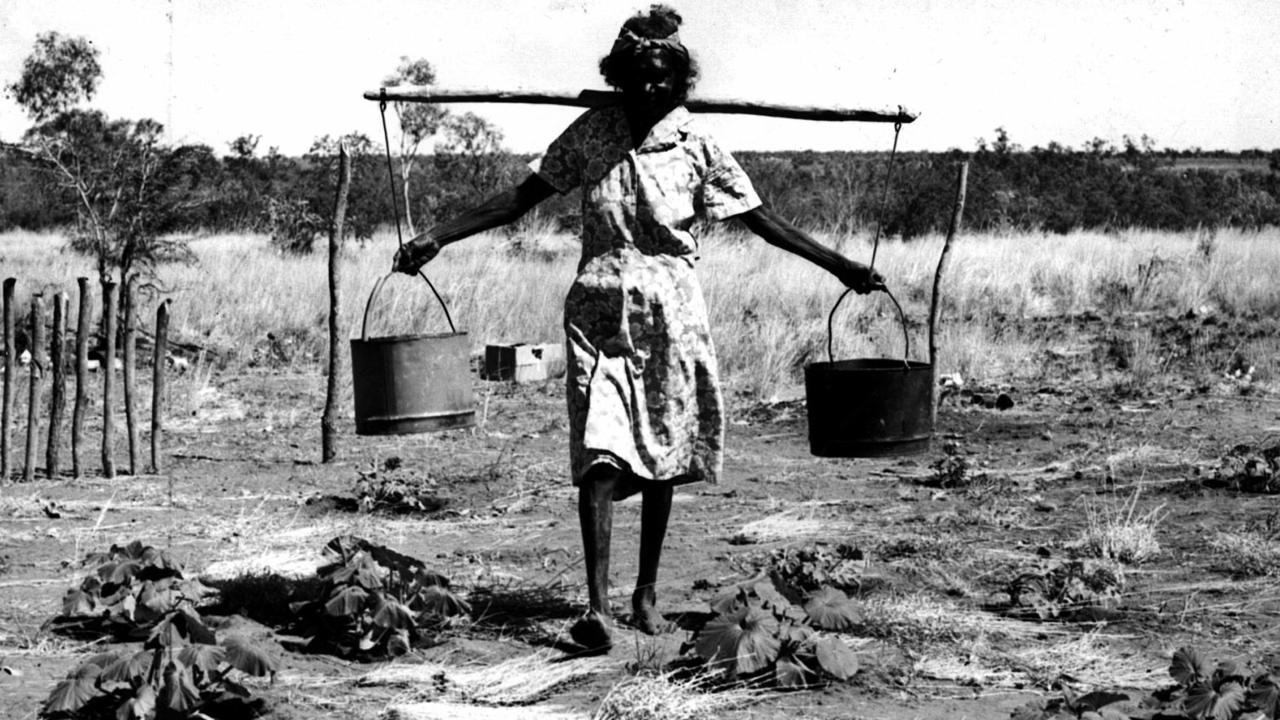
xmin=40 ymin=607 xmax=276 ymax=720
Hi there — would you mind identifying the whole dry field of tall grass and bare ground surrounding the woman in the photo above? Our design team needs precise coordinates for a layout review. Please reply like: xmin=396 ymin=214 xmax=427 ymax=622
xmin=0 ymin=225 xmax=1280 ymax=720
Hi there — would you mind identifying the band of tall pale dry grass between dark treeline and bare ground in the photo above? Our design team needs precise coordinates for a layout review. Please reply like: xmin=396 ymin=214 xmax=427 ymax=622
xmin=0 ymin=228 xmax=1280 ymax=398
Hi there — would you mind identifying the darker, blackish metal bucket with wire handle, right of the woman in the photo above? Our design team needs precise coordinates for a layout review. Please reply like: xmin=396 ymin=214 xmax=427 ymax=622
xmin=804 ymin=285 xmax=933 ymax=457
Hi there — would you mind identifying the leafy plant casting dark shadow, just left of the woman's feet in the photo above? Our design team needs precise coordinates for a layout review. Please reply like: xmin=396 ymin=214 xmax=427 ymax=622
xmin=292 ymin=536 xmax=471 ymax=660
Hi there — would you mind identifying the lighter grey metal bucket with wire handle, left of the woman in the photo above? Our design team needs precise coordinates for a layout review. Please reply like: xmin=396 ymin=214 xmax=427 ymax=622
xmin=351 ymin=274 xmax=475 ymax=436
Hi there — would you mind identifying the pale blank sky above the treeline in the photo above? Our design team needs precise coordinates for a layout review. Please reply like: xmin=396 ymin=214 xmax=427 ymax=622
xmin=0 ymin=0 xmax=1280 ymax=155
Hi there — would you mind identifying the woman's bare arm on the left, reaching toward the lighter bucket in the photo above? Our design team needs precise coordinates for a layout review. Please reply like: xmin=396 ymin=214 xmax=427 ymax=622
xmin=392 ymin=174 xmax=556 ymax=275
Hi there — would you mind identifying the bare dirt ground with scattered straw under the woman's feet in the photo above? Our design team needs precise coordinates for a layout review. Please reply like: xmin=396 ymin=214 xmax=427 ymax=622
xmin=0 ymin=311 xmax=1280 ymax=720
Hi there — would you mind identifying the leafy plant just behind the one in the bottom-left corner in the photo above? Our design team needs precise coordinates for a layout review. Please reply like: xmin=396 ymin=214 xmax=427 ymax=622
xmin=50 ymin=541 xmax=212 ymax=639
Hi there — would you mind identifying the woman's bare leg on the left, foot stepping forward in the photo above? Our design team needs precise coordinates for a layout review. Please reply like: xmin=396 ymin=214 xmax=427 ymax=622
xmin=570 ymin=465 xmax=621 ymax=651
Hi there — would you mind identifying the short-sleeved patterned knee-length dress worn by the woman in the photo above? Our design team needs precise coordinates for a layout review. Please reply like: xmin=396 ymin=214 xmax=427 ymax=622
xmin=535 ymin=106 xmax=760 ymax=484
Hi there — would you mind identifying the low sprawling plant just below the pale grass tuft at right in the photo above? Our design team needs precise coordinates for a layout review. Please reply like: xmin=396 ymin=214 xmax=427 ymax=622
xmin=1005 ymin=560 xmax=1124 ymax=620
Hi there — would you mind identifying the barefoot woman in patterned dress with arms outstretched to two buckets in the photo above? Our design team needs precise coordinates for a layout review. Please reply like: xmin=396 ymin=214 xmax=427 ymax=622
xmin=396 ymin=5 xmax=882 ymax=651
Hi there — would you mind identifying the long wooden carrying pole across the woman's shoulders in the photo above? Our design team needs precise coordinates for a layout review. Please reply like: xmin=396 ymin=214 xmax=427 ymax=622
xmin=365 ymin=85 xmax=919 ymax=123
